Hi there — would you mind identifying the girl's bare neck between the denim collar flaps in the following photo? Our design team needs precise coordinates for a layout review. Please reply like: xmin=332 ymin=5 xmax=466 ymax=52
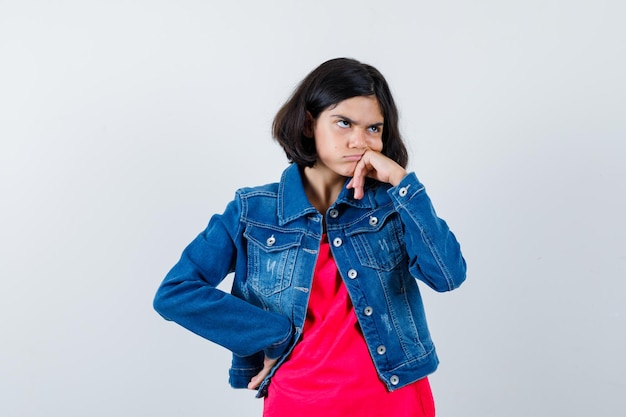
xmin=303 ymin=167 xmax=346 ymax=214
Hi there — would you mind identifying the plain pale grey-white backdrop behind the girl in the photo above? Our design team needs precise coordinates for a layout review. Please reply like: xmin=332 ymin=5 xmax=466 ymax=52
xmin=0 ymin=0 xmax=626 ymax=417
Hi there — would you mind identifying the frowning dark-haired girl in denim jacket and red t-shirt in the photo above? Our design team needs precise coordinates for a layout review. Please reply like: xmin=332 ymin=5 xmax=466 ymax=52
xmin=154 ymin=58 xmax=465 ymax=417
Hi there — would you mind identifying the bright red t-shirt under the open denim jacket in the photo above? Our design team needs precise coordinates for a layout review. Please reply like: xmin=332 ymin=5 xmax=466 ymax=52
xmin=263 ymin=236 xmax=435 ymax=417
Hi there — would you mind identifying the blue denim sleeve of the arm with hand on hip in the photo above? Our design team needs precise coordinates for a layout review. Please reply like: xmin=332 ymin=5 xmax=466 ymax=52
xmin=153 ymin=195 xmax=293 ymax=358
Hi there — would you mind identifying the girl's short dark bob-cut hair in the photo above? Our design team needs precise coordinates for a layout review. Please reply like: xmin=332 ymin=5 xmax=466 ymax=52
xmin=272 ymin=58 xmax=409 ymax=168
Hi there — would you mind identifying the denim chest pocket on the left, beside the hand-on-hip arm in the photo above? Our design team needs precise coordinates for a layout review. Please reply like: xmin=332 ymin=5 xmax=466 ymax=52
xmin=244 ymin=226 xmax=302 ymax=297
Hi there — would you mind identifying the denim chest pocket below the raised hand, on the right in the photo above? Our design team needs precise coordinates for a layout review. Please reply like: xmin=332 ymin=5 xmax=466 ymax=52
xmin=346 ymin=212 xmax=406 ymax=271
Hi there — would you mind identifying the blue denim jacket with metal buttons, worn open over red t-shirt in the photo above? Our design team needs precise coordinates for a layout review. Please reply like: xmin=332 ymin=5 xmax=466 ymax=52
xmin=154 ymin=164 xmax=465 ymax=396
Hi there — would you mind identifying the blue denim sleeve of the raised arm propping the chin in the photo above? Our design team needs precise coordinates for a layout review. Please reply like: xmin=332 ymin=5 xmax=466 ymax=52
xmin=387 ymin=173 xmax=466 ymax=292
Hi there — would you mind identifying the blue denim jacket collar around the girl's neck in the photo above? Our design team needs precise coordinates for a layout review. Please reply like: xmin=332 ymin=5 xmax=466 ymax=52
xmin=278 ymin=163 xmax=376 ymax=226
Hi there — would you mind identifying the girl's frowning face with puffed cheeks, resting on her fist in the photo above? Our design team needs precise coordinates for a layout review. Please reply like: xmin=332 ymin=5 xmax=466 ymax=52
xmin=313 ymin=96 xmax=384 ymax=177
